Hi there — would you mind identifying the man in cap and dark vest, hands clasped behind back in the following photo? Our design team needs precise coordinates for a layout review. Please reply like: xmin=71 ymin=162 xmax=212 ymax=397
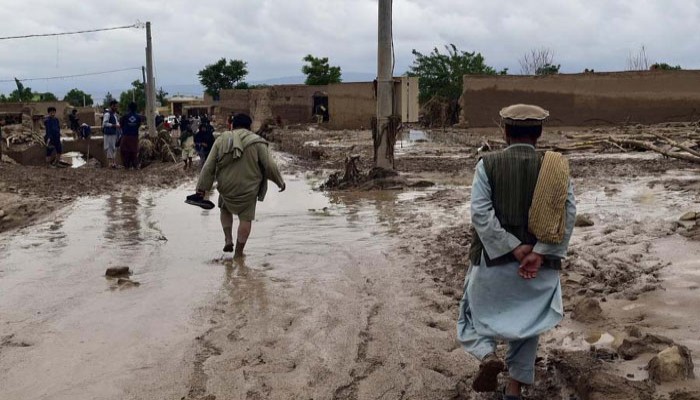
xmin=457 ymin=104 xmax=576 ymax=400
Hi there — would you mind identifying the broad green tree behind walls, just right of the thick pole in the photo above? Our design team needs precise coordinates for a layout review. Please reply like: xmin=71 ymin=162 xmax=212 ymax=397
xmin=408 ymin=44 xmax=508 ymax=104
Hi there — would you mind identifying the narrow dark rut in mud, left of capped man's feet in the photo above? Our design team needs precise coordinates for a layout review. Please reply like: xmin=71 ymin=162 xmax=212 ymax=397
xmin=333 ymin=304 xmax=383 ymax=400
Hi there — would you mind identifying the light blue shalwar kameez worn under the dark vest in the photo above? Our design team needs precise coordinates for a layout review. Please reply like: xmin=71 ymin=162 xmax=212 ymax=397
xmin=457 ymin=144 xmax=576 ymax=384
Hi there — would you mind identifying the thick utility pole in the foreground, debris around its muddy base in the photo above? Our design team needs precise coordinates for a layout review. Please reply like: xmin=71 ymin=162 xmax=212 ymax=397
xmin=374 ymin=0 xmax=394 ymax=169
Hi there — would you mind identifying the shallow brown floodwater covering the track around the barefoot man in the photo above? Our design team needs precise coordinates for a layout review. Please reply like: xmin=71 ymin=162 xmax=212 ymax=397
xmin=0 ymin=177 xmax=434 ymax=400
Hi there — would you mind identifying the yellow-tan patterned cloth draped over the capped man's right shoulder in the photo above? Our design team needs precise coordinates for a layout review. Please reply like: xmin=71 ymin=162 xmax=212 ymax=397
xmin=528 ymin=151 xmax=569 ymax=244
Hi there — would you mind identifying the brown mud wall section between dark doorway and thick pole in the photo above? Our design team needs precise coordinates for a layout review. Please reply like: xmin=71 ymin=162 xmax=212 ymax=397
xmin=328 ymin=82 xmax=377 ymax=129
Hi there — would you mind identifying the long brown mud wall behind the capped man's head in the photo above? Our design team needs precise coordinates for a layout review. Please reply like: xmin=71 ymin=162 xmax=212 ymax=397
xmin=460 ymin=71 xmax=700 ymax=127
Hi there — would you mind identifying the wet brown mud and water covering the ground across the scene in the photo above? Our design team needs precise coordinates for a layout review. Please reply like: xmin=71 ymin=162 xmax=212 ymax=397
xmin=0 ymin=124 xmax=700 ymax=400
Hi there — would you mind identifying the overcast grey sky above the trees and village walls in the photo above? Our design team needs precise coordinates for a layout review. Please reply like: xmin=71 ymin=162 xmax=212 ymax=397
xmin=0 ymin=0 xmax=700 ymax=98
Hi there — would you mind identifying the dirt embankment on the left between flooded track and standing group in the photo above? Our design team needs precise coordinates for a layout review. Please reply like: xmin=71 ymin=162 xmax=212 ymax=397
xmin=0 ymin=163 xmax=194 ymax=232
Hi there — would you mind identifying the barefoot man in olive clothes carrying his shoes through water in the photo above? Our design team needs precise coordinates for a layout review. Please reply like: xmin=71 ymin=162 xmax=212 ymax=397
xmin=186 ymin=114 xmax=286 ymax=258
